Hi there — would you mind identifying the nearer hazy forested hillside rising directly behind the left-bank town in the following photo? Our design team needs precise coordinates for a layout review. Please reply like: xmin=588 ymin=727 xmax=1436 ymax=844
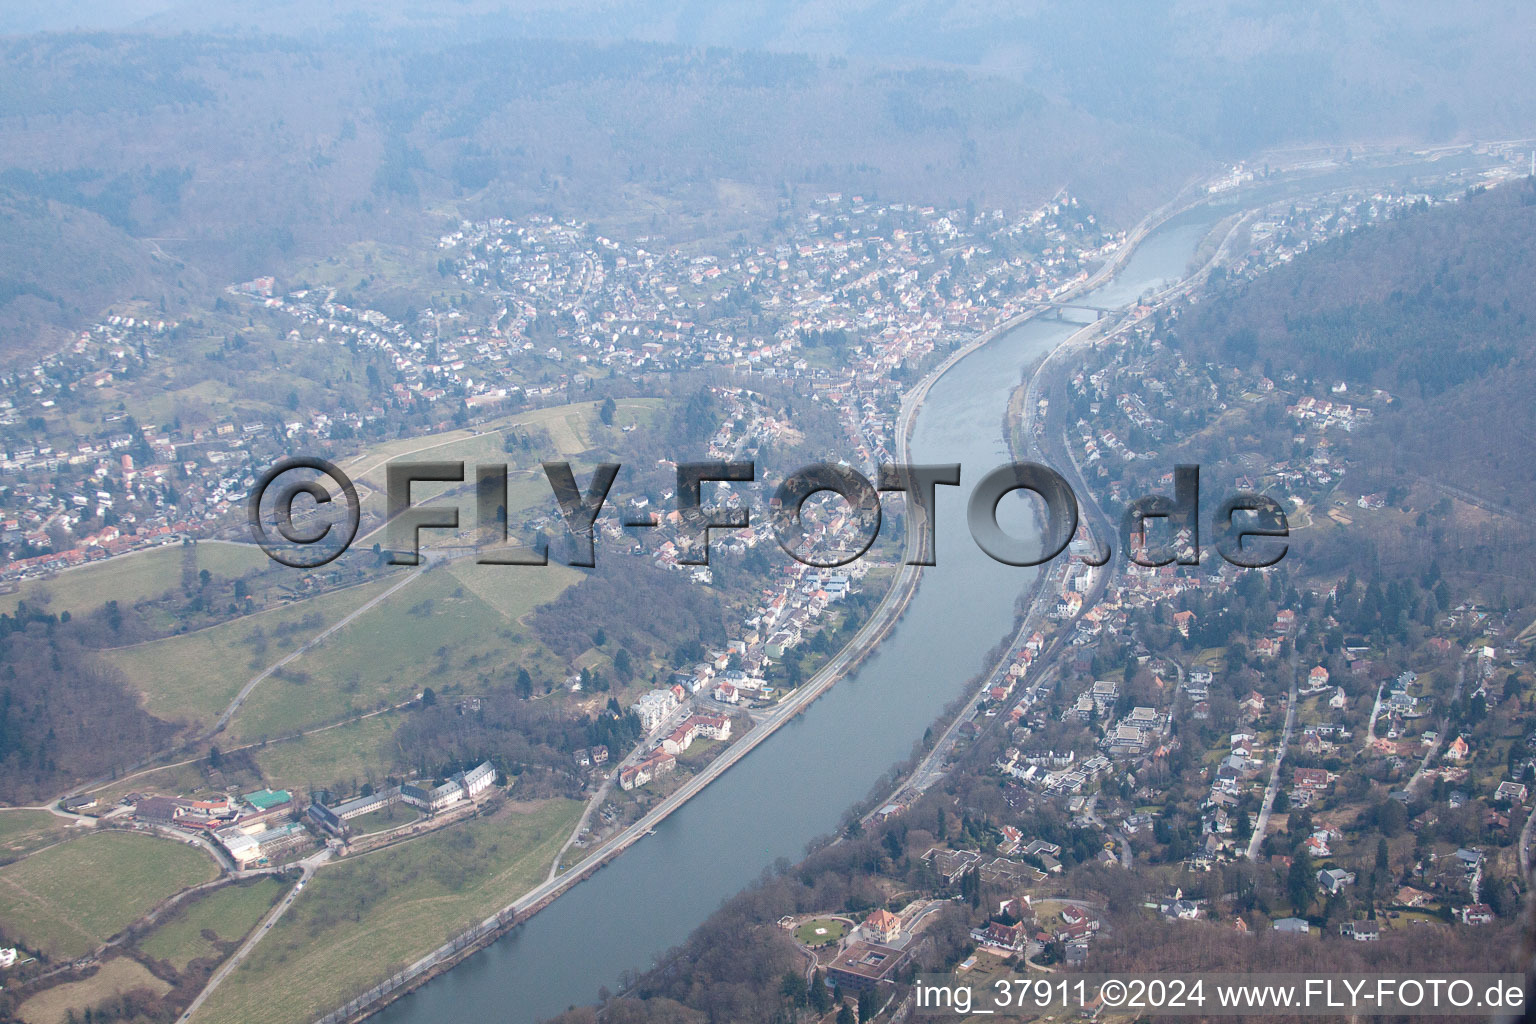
xmin=0 ymin=35 xmax=1207 ymax=359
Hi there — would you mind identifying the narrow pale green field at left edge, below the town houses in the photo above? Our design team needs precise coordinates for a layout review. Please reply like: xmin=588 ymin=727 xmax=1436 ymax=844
xmin=0 ymin=543 xmax=269 ymax=616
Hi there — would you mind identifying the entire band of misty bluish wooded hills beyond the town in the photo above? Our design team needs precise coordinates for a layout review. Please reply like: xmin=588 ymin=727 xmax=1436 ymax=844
xmin=0 ymin=0 xmax=1536 ymax=356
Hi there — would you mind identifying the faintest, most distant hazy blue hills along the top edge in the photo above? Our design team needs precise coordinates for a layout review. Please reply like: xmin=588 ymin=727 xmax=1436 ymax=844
xmin=12 ymin=0 xmax=1536 ymax=155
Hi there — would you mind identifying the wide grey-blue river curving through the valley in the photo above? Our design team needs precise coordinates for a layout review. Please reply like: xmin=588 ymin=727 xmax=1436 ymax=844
xmin=375 ymin=150 xmax=1486 ymax=1024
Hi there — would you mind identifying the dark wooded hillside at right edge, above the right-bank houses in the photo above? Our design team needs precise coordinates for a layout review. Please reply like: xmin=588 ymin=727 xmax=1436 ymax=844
xmin=1178 ymin=181 xmax=1536 ymax=510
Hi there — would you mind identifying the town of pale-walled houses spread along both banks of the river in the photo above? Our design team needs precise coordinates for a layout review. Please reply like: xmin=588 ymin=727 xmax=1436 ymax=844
xmin=0 ymin=142 xmax=1536 ymax=1019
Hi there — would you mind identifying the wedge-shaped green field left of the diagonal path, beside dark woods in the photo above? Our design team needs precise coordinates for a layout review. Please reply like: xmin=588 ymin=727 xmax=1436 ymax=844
xmin=106 ymin=577 xmax=395 ymax=725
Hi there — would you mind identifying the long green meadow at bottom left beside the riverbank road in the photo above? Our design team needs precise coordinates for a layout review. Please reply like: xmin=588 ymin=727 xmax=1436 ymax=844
xmin=200 ymin=800 xmax=581 ymax=1024
